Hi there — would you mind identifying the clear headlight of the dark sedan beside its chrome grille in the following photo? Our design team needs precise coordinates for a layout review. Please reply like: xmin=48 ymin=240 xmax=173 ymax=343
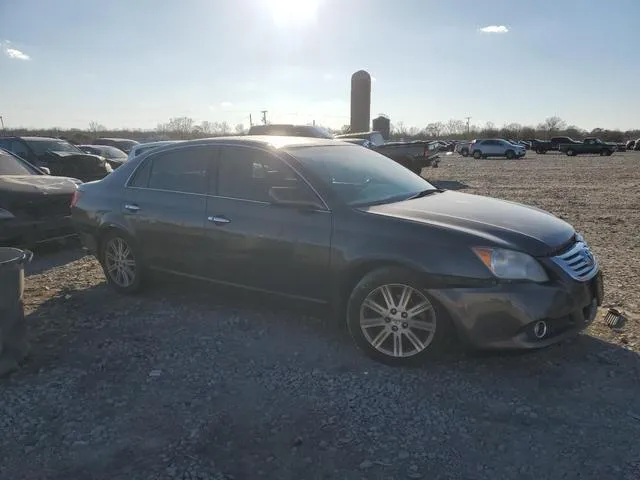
xmin=473 ymin=247 xmax=549 ymax=282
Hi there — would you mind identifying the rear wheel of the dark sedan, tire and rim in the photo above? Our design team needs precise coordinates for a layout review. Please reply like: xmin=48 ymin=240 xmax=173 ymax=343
xmin=99 ymin=231 xmax=143 ymax=294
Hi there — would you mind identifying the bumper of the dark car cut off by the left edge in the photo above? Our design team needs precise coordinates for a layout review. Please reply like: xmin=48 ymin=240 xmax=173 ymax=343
xmin=0 ymin=216 xmax=75 ymax=246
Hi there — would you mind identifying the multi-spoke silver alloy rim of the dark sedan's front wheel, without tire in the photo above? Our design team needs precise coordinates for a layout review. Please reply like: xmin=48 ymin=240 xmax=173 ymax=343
xmin=360 ymin=284 xmax=436 ymax=358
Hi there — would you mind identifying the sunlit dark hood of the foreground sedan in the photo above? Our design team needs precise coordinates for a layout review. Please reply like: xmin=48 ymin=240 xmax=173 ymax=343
xmin=364 ymin=190 xmax=575 ymax=256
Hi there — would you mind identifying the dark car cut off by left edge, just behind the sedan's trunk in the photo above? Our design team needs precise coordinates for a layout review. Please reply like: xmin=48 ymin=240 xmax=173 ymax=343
xmin=0 ymin=148 xmax=82 ymax=248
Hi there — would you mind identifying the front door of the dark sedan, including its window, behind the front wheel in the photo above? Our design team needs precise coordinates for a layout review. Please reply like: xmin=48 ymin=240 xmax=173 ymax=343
xmin=205 ymin=146 xmax=332 ymax=301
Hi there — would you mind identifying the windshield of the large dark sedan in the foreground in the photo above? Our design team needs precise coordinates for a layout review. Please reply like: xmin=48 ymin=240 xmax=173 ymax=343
xmin=287 ymin=145 xmax=437 ymax=207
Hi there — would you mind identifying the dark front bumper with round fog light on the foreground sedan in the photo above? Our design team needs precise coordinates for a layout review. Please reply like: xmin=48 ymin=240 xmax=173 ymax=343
xmin=429 ymin=273 xmax=602 ymax=349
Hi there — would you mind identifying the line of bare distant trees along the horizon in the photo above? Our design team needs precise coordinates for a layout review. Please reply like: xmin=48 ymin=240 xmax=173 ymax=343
xmin=2 ymin=116 xmax=640 ymax=144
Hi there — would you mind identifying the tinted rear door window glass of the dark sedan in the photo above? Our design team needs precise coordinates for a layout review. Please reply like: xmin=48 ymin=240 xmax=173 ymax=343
xmin=148 ymin=147 xmax=211 ymax=193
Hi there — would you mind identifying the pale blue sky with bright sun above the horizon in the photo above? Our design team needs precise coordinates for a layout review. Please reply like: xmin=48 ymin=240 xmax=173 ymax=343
xmin=0 ymin=0 xmax=640 ymax=130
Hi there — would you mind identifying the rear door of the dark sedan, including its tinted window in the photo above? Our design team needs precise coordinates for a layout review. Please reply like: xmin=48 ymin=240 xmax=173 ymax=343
xmin=122 ymin=145 xmax=215 ymax=274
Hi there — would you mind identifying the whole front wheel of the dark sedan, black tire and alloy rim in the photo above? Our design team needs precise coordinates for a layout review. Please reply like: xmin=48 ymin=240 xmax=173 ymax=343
xmin=347 ymin=267 xmax=450 ymax=365
